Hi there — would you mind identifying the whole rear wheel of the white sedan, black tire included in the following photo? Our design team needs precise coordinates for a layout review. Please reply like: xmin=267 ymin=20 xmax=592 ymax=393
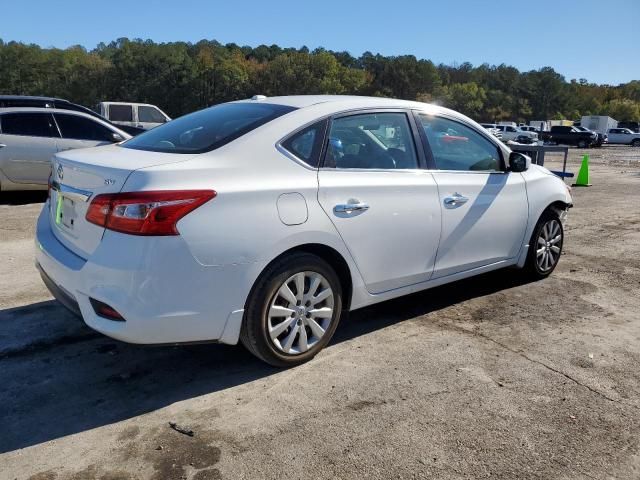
xmin=240 ymin=252 xmax=342 ymax=367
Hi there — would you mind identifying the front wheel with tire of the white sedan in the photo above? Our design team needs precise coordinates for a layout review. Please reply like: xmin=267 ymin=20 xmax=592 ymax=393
xmin=524 ymin=208 xmax=564 ymax=280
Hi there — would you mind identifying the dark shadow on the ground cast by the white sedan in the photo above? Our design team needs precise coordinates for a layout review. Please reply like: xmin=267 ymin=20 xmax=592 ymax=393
xmin=0 ymin=271 xmax=524 ymax=453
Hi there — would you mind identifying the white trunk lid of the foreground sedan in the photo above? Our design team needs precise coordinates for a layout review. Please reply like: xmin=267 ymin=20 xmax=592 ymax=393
xmin=49 ymin=145 xmax=193 ymax=259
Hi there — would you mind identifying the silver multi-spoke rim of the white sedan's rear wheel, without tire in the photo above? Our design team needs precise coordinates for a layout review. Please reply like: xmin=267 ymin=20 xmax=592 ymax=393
xmin=267 ymin=271 xmax=334 ymax=355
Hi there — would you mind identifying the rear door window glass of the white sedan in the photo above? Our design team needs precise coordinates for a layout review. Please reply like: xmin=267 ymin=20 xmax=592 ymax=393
xmin=324 ymin=113 xmax=418 ymax=169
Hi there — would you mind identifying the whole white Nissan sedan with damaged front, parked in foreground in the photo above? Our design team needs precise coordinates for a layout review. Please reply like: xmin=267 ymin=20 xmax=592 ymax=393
xmin=36 ymin=96 xmax=572 ymax=366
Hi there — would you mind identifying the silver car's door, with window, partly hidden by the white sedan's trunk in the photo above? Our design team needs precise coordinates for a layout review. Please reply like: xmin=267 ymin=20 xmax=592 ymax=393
xmin=53 ymin=112 xmax=116 ymax=152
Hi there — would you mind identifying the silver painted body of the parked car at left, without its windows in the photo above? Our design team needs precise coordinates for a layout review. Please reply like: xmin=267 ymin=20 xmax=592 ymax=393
xmin=0 ymin=107 xmax=131 ymax=191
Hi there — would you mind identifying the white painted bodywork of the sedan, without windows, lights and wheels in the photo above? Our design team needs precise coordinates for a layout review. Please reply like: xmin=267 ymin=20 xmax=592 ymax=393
xmin=36 ymin=96 xmax=571 ymax=344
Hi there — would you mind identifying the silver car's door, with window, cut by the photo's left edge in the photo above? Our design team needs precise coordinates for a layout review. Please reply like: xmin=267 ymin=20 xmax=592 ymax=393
xmin=0 ymin=112 xmax=59 ymax=185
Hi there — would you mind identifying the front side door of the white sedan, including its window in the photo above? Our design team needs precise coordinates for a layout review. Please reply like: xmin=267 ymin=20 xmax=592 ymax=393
xmin=417 ymin=113 xmax=529 ymax=278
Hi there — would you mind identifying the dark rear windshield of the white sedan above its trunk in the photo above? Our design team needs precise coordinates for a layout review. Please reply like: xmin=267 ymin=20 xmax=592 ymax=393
xmin=122 ymin=103 xmax=295 ymax=153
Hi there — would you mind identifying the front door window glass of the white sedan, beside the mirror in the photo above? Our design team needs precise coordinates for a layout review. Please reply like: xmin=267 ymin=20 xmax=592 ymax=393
xmin=420 ymin=114 xmax=501 ymax=171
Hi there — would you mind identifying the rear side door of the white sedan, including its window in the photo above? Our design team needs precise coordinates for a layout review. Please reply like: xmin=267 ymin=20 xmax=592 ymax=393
xmin=318 ymin=111 xmax=440 ymax=293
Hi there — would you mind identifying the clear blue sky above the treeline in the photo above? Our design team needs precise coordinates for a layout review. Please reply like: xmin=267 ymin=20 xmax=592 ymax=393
xmin=0 ymin=0 xmax=640 ymax=84
